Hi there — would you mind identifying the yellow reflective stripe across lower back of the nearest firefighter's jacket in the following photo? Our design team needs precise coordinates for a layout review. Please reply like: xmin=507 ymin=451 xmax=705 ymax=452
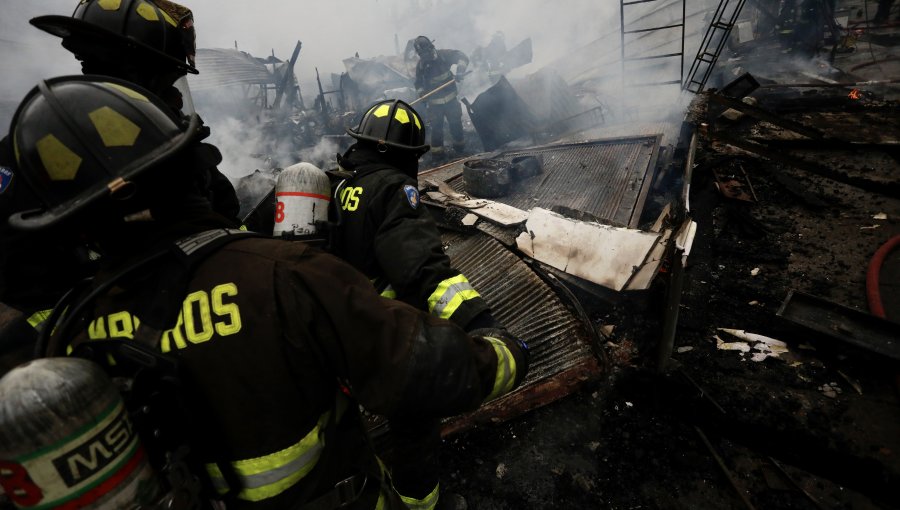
xmin=206 ymin=412 xmax=331 ymax=501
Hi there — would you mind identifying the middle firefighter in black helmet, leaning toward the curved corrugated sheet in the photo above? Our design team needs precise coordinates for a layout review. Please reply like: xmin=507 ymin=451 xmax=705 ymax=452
xmin=331 ymin=100 xmax=508 ymax=508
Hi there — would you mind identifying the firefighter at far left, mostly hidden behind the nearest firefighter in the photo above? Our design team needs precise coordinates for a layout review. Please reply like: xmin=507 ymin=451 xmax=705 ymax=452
xmin=0 ymin=0 xmax=240 ymax=356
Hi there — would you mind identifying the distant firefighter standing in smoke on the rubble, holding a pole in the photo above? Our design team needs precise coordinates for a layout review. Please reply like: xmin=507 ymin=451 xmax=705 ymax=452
xmin=413 ymin=35 xmax=469 ymax=161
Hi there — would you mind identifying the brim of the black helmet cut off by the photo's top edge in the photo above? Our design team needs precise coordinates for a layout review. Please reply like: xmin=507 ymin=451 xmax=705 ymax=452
xmin=29 ymin=14 xmax=199 ymax=74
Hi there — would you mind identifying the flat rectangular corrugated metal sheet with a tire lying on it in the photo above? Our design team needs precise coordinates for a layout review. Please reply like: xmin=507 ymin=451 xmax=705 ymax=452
xmin=449 ymin=136 xmax=659 ymax=228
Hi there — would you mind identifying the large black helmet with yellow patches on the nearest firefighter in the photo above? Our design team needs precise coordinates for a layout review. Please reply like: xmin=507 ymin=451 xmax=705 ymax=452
xmin=9 ymin=76 xmax=200 ymax=230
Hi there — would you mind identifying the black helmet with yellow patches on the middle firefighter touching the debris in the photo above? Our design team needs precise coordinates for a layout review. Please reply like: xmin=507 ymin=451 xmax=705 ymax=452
xmin=347 ymin=99 xmax=431 ymax=156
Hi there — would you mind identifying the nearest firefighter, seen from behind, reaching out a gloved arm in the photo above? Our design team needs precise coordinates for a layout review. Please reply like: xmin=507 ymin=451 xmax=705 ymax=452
xmin=9 ymin=76 xmax=528 ymax=510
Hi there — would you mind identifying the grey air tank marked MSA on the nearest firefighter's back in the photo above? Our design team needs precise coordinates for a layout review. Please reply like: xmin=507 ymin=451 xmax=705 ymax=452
xmin=0 ymin=358 xmax=162 ymax=509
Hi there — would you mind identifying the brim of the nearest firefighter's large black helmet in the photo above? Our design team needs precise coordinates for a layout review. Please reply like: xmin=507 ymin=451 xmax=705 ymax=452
xmin=9 ymin=113 xmax=202 ymax=230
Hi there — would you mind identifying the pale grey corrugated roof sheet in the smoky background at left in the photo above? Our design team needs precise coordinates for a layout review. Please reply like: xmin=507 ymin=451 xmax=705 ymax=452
xmin=188 ymin=48 xmax=275 ymax=90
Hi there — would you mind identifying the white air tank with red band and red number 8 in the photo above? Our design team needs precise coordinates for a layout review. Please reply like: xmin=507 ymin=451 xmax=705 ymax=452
xmin=272 ymin=163 xmax=331 ymax=237
